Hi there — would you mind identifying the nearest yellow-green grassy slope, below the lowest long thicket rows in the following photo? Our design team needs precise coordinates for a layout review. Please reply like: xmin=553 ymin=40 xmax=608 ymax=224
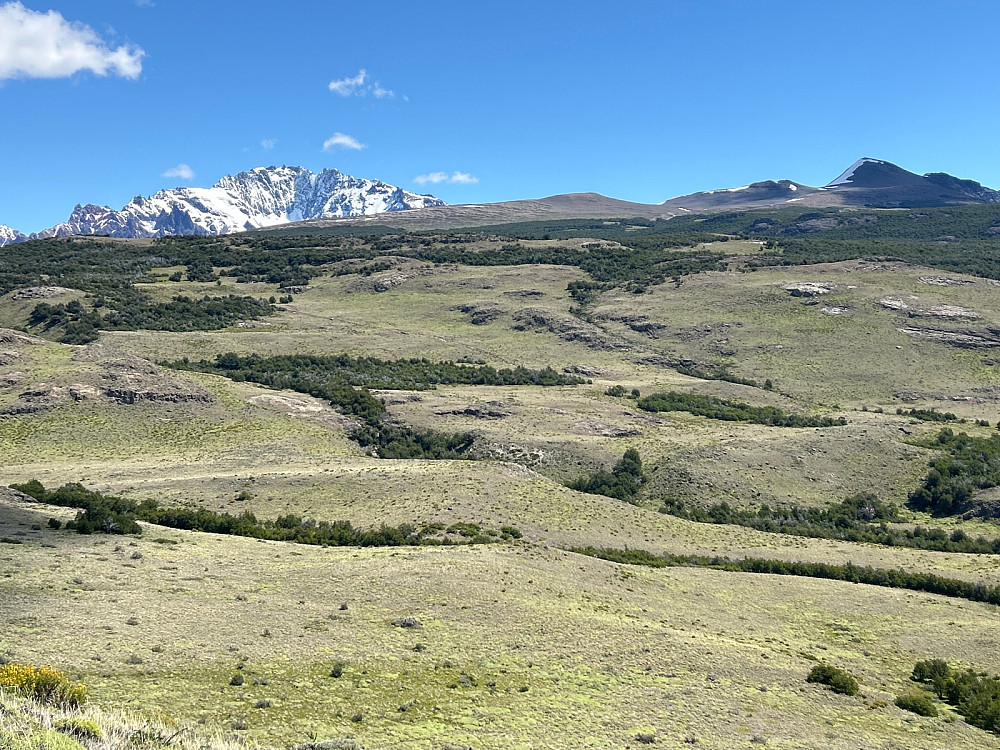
xmin=0 ymin=500 xmax=1000 ymax=748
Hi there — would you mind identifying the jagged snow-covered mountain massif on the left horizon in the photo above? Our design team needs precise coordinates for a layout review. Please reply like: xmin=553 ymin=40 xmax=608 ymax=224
xmin=31 ymin=167 xmax=445 ymax=239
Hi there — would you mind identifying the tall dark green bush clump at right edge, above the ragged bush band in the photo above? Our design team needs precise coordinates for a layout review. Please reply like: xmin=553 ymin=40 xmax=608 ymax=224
xmin=907 ymin=427 xmax=1000 ymax=516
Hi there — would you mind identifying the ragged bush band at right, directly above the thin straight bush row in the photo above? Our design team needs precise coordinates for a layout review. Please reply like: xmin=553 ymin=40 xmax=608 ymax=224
xmin=660 ymin=492 xmax=1000 ymax=554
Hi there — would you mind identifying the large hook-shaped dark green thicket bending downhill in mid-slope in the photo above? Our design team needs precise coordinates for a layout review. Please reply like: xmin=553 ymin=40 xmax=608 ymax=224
xmin=163 ymin=352 xmax=584 ymax=459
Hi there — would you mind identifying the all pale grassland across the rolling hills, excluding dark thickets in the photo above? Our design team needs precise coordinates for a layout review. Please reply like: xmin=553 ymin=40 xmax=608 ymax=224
xmin=0 ymin=251 xmax=1000 ymax=749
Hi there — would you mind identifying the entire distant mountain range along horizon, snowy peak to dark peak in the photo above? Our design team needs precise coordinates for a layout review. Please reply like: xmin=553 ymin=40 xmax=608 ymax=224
xmin=0 ymin=158 xmax=1000 ymax=247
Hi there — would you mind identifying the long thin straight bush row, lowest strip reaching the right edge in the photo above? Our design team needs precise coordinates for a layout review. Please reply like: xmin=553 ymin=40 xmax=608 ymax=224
xmin=572 ymin=547 xmax=1000 ymax=605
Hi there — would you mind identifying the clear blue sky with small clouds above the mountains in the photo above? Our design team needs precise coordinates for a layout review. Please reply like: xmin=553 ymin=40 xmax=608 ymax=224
xmin=0 ymin=0 xmax=1000 ymax=232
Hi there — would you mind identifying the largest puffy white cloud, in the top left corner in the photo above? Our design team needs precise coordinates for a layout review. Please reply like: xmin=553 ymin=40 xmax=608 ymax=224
xmin=0 ymin=2 xmax=146 ymax=80
